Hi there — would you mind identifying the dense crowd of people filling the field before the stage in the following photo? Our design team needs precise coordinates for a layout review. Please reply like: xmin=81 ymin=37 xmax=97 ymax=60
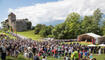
xmin=0 ymin=34 xmax=105 ymax=60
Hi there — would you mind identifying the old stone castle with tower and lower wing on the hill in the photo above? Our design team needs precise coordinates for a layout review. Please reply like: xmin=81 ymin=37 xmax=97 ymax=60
xmin=5 ymin=13 xmax=32 ymax=32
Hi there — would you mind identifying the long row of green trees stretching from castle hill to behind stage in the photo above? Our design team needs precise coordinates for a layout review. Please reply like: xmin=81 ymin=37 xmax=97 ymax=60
xmin=34 ymin=9 xmax=105 ymax=39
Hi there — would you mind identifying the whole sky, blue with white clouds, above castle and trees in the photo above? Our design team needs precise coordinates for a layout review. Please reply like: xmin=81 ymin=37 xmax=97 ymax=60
xmin=0 ymin=0 xmax=105 ymax=25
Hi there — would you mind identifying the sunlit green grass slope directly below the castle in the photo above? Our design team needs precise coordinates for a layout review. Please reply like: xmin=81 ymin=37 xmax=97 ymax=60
xmin=17 ymin=30 xmax=42 ymax=41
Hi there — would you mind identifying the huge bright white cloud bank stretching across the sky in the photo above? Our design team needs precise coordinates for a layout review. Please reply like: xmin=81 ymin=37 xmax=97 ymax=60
xmin=9 ymin=0 xmax=105 ymax=25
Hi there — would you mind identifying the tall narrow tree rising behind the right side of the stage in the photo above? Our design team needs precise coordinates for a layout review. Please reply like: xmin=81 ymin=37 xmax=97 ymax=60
xmin=92 ymin=8 xmax=103 ymax=35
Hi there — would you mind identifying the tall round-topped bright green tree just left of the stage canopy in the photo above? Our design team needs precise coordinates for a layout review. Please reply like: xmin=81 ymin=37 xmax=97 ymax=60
xmin=65 ymin=12 xmax=80 ymax=38
